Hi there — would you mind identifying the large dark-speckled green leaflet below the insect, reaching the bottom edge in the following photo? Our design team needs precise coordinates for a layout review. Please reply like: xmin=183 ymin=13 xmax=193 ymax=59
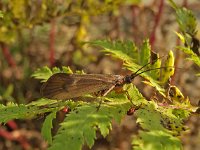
xmin=49 ymin=97 xmax=131 ymax=150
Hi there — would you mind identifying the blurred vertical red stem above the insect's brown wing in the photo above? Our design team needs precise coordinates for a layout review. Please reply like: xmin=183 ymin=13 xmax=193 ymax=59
xmin=49 ymin=19 xmax=56 ymax=67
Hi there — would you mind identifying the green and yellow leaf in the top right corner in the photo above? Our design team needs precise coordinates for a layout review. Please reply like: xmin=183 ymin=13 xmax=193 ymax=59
xmin=169 ymin=0 xmax=200 ymax=69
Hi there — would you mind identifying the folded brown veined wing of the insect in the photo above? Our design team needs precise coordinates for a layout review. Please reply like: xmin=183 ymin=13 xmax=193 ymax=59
xmin=41 ymin=73 xmax=118 ymax=99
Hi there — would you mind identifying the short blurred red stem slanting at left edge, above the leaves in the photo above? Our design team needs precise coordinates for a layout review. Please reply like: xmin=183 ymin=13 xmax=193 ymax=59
xmin=0 ymin=42 xmax=17 ymax=68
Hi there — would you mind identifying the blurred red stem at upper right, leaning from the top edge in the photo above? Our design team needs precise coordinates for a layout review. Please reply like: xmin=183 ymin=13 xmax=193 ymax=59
xmin=150 ymin=0 xmax=164 ymax=48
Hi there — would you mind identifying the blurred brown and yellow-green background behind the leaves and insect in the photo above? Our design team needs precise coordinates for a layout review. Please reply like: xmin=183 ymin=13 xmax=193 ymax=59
xmin=0 ymin=0 xmax=200 ymax=150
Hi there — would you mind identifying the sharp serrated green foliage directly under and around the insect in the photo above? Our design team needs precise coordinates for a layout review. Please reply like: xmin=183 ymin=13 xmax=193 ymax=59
xmin=0 ymin=37 xmax=195 ymax=150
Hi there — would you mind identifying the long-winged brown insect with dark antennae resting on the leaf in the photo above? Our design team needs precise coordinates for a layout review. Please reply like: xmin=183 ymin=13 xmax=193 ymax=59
xmin=41 ymin=61 xmax=169 ymax=100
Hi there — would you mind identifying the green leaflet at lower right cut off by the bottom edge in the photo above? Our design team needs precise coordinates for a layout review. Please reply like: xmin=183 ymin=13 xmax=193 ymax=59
xmin=132 ymin=130 xmax=182 ymax=150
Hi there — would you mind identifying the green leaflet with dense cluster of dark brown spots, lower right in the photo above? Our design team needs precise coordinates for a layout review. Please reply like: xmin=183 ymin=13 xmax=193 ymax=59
xmin=135 ymin=101 xmax=190 ymax=135
